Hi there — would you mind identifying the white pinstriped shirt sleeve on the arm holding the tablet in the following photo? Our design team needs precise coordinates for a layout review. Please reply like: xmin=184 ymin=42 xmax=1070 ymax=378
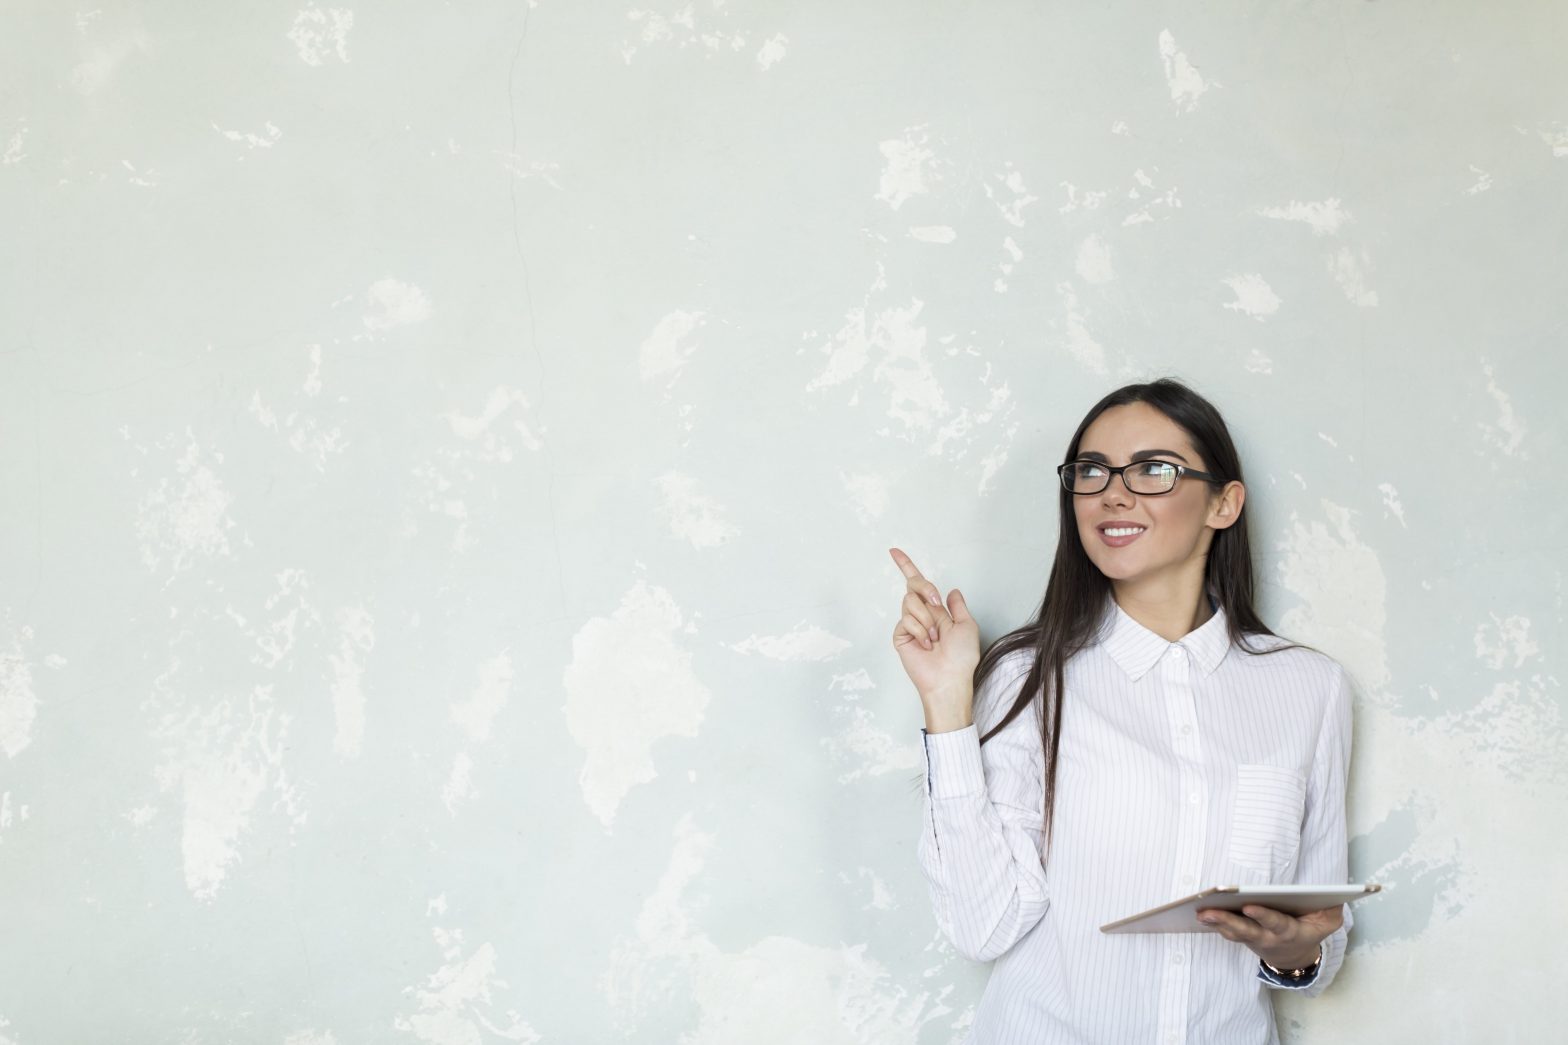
xmin=1258 ymin=664 xmax=1355 ymax=998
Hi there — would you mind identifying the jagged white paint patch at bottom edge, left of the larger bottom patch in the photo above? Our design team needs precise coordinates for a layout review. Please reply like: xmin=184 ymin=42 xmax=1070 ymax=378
xmin=392 ymin=927 xmax=539 ymax=1045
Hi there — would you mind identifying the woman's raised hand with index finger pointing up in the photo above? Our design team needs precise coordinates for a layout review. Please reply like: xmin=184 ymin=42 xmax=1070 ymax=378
xmin=887 ymin=548 xmax=980 ymax=715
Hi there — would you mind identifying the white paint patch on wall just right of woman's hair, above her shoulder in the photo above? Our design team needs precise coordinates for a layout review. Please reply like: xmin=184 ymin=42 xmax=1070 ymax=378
xmin=1276 ymin=499 xmax=1389 ymax=698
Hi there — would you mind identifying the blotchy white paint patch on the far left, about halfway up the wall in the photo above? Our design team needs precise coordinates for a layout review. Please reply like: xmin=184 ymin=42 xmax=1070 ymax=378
xmin=132 ymin=427 xmax=235 ymax=573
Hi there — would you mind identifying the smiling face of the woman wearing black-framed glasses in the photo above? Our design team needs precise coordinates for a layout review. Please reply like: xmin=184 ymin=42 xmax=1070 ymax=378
xmin=1073 ymin=403 xmax=1243 ymax=582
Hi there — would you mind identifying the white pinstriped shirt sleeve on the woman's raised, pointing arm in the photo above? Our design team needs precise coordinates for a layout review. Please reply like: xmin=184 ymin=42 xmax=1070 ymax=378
xmin=919 ymin=661 xmax=1051 ymax=962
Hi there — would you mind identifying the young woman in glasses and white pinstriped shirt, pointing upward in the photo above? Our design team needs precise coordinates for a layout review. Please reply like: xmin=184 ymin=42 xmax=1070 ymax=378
xmin=891 ymin=378 xmax=1352 ymax=1045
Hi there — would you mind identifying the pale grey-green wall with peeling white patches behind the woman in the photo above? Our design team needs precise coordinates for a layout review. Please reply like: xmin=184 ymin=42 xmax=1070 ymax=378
xmin=0 ymin=0 xmax=1568 ymax=1045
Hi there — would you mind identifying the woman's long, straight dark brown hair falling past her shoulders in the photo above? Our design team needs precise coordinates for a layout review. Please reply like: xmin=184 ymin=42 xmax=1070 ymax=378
xmin=974 ymin=378 xmax=1311 ymax=843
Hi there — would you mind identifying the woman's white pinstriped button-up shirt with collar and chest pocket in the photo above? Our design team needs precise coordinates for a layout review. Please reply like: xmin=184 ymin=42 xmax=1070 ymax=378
xmin=917 ymin=596 xmax=1352 ymax=1045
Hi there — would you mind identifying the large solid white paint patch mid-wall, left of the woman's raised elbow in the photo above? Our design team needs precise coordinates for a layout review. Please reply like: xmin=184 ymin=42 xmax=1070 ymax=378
xmin=561 ymin=579 xmax=710 ymax=827
